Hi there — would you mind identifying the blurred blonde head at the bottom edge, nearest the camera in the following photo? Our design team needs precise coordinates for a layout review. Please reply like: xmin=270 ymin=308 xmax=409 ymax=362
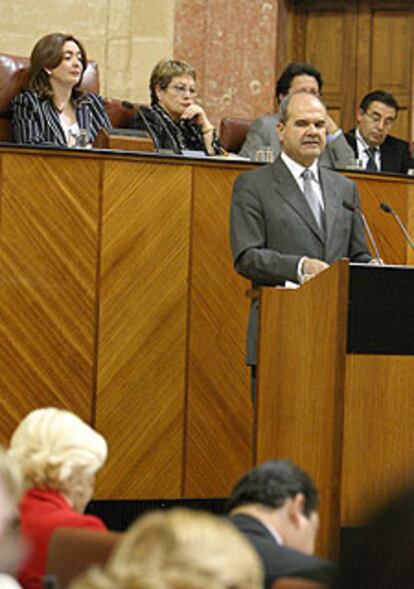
xmin=71 ymin=509 xmax=263 ymax=589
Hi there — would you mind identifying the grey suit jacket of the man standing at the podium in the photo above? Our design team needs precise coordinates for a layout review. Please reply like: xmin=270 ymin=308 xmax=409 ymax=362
xmin=230 ymin=157 xmax=371 ymax=365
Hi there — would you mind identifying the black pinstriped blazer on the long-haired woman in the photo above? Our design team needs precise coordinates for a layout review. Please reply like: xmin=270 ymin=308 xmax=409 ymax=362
xmin=12 ymin=90 xmax=111 ymax=145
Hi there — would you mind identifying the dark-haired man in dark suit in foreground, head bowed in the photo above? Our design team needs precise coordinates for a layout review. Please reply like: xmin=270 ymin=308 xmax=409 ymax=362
xmin=229 ymin=460 xmax=335 ymax=587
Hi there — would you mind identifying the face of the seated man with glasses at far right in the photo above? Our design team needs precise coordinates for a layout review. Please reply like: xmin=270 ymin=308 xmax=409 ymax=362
xmin=357 ymin=100 xmax=397 ymax=147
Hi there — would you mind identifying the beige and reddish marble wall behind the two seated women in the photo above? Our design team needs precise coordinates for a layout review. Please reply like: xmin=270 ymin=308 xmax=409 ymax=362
xmin=0 ymin=0 xmax=284 ymax=124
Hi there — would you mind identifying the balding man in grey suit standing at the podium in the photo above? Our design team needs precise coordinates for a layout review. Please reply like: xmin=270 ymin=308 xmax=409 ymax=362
xmin=230 ymin=92 xmax=371 ymax=390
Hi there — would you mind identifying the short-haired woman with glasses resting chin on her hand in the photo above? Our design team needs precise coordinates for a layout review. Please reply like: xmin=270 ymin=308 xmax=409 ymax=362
xmin=131 ymin=59 xmax=223 ymax=155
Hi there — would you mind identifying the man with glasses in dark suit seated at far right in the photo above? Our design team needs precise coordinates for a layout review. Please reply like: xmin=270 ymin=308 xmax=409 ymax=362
xmin=345 ymin=90 xmax=414 ymax=174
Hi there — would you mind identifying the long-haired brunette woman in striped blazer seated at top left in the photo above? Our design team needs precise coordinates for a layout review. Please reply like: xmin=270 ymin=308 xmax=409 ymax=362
xmin=12 ymin=33 xmax=110 ymax=146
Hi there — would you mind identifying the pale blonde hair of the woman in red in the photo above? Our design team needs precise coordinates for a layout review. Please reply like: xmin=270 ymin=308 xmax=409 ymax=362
xmin=9 ymin=407 xmax=108 ymax=491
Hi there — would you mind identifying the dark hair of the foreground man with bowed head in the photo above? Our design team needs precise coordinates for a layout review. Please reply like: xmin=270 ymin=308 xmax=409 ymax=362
xmin=227 ymin=460 xmax=319 ymax=517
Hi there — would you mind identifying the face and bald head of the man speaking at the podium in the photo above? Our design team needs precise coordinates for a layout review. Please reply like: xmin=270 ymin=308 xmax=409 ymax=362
xmin=276 ymin=93 xmax=326 ymax=167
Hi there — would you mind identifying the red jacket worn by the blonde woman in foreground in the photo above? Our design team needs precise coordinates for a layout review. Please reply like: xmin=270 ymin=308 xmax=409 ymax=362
xmin=18 ymin=488 xmax=107 ymax=589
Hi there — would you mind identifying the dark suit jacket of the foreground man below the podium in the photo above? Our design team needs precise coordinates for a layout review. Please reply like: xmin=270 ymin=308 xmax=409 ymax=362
xmin=230 ymin=514 xmax=336 ymax=588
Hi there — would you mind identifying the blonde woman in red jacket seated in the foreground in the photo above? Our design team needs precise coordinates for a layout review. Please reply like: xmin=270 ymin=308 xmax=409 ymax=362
xmin=9 ymin=407 xmax=107 ymax=589
